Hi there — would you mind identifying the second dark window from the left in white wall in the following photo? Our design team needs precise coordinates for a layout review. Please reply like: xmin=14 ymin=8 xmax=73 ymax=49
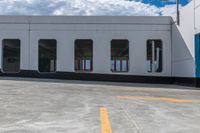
xmin=39 ymin=39 xmax=57 ymax=72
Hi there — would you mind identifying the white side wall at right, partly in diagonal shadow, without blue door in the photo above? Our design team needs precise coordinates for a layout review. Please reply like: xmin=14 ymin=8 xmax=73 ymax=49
xmin=172 ymin=1 xmax=195 ymax=77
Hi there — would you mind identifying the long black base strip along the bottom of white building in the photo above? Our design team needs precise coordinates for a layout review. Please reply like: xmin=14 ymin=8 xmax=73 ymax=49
xmin=0 ymin=70 xmax=197 ymax=87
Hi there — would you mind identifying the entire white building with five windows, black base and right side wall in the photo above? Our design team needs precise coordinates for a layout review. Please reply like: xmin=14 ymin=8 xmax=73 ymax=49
xmin=0 ymin=0 xmax=200 ymax=85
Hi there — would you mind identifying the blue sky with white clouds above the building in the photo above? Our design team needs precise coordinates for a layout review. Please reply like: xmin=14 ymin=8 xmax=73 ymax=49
xmin=0 ymin=0 xmax=188 ymax=16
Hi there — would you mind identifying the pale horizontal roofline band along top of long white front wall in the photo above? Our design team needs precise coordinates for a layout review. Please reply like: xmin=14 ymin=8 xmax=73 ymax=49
xmin=0 ymin=16 xmax=173 ymax=25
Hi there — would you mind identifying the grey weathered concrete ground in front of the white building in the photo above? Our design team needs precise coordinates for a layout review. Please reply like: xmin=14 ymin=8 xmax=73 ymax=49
xmin=0 ymin=78 xmax=200 ymax=133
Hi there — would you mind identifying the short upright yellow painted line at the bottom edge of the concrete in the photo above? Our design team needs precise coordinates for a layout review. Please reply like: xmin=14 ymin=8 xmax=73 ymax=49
xmin=100 ymin=107 xmax=112 ymax=133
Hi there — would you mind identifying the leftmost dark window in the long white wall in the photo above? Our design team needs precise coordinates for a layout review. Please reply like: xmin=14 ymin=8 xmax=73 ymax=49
xmin=2 ymin=39 xmax=20 ymax=73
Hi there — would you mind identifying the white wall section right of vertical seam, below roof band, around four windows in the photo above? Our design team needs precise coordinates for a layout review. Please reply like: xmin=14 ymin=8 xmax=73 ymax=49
xmin=30 ymin=24 xmax=171 ymax=76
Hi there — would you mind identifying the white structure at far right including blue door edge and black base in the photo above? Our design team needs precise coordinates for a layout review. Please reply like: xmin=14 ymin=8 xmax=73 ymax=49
xmin=172 ymin=0 xmax=200 ymax=86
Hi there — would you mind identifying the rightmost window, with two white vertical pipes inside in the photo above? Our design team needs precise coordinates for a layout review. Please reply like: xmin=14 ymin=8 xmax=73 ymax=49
xmin=147 ymin=40 xmax=163 ymax=72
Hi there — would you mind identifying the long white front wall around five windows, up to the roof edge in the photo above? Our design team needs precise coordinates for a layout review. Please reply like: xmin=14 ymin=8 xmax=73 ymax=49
xmin=0 ymin=17 xmax=172 ymax=76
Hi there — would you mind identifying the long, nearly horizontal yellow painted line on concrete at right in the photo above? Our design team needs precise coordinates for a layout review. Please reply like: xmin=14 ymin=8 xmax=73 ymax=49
xmin=117 ymin=96 xmax=194 ymax=103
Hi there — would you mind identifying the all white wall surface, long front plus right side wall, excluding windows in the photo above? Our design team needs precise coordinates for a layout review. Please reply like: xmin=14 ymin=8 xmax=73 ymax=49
xmin=0 ymin=10 xmax=197 ymax=77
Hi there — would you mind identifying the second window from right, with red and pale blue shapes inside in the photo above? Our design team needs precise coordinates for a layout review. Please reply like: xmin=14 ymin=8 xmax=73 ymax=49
xmin=111 ymin=40 xmax=129 ymax=72
